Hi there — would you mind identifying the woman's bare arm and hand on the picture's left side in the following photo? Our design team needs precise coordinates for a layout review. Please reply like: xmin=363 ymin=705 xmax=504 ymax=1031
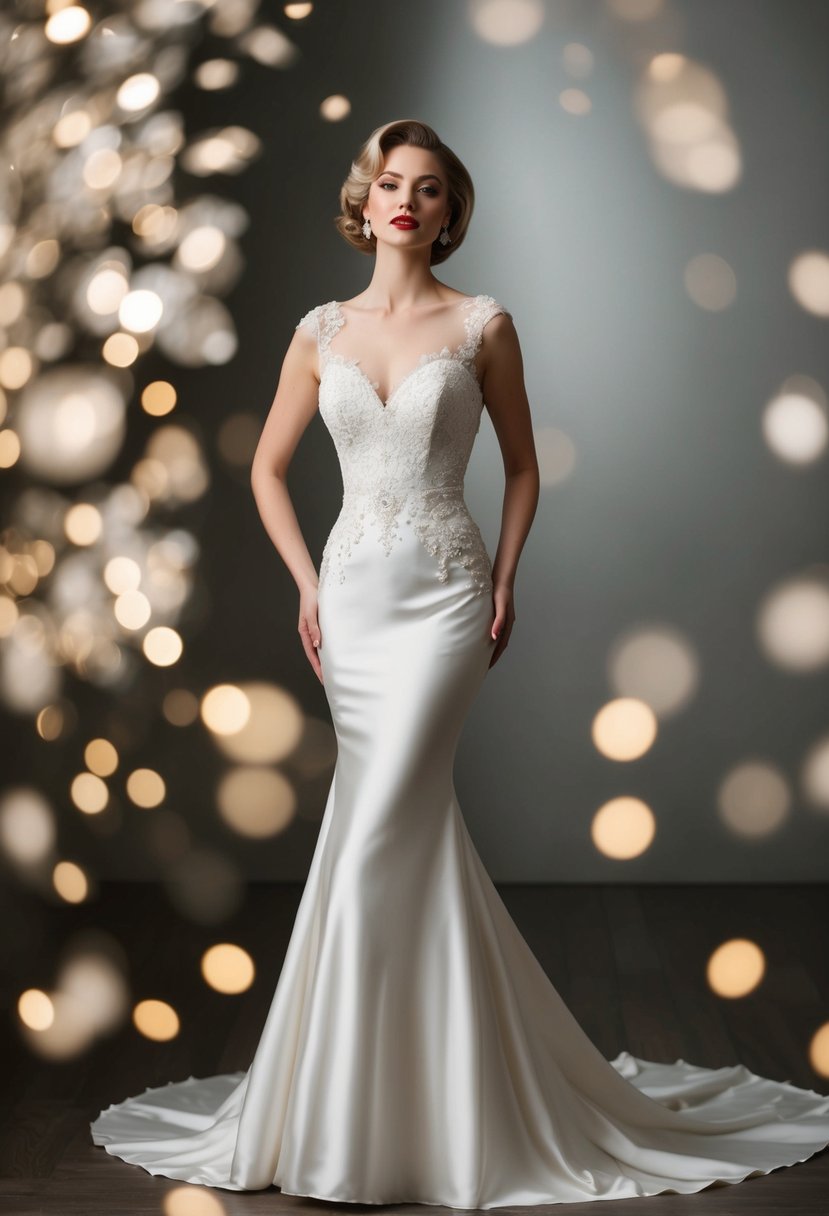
xmin=250 ymin=327 xmax=322 ymax=682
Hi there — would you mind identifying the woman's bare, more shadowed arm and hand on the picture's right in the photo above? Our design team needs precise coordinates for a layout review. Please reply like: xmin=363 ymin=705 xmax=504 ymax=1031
xmin=481 ymin=314 xmax=540 ymax=666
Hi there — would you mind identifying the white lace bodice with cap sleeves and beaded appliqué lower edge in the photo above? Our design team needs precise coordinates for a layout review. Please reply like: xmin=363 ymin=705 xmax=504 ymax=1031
xmin=297 ymin=295 xmax=509 ymax=593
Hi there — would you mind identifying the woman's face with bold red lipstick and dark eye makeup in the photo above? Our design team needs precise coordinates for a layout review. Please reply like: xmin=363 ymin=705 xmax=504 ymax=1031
xmin=362 ymin=145 xmax=451 ymax=248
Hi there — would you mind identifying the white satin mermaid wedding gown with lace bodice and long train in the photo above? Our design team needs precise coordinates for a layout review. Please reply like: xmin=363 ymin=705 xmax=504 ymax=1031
xmin=90 ymin=295 xmax=829 ymax=1209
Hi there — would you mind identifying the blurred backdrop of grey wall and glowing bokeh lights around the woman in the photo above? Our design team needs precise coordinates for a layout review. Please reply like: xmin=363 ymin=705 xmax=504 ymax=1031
xmin=0 ymin=0 xmax=829 ymax=1118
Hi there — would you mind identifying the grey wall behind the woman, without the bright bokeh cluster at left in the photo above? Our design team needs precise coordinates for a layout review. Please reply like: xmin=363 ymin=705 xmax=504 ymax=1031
xmin=4 ymin=0 xmax=829 ymax=882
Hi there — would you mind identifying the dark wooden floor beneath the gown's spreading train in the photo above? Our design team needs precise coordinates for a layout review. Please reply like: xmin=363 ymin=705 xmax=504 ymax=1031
xmin=0 ymin=884 xmax=829 ymax=1216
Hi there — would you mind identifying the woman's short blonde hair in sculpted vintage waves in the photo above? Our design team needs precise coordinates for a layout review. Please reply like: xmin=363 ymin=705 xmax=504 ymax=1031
xmin=334 ymin=118 xmax=475 ymax=266
